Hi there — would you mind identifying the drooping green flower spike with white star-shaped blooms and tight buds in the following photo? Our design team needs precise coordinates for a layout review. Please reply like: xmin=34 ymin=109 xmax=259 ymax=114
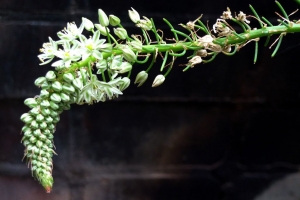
xmin=21 ymin=1 xmax=300 ymax=192
